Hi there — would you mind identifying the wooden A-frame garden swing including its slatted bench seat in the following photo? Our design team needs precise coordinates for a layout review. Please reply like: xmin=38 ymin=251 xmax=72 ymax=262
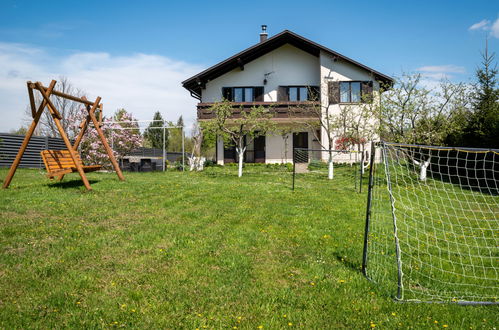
xmin=3 ymin=80 xmax=125 ymax=190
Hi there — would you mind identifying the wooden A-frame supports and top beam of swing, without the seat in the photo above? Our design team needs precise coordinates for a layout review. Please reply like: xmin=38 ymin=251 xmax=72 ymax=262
xmin=3 ymin=80 xmax=125 ymax=190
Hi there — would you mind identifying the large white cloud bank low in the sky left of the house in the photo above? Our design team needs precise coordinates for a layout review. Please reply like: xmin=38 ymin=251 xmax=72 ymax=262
xmin=0 ymin=43 xmax=202 ymax=132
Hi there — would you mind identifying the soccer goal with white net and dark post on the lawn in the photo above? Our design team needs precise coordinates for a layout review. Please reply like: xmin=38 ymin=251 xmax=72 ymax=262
xmin=362 ymin=142 xmax=499 ymax=304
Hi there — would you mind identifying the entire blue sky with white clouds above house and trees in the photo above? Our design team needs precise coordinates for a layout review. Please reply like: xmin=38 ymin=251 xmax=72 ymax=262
xmin=0 ymin=0 xmax=499 ymax=131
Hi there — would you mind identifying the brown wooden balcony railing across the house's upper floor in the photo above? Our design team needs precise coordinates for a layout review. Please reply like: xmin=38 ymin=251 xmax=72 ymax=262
xmin=197 ymin=101 xmax=320 ymax=120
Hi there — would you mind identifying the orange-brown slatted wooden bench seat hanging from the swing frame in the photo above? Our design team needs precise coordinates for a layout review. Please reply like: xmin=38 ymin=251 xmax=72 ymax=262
xmin=40 ymin=150 xmax=102 ymax=180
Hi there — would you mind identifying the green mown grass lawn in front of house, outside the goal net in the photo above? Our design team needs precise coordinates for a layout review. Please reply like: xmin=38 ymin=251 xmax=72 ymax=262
xmin=0 ymin=167 xmax=499 ymax=329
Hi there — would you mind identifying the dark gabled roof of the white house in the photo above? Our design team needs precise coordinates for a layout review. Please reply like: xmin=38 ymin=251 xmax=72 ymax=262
xmin=182 ymin=30 xmax=394 ymax=97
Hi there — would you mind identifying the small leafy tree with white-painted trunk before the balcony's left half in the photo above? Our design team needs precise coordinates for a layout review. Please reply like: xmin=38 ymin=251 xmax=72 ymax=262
xmin=203 ymin=100 xmax=275 ymax=177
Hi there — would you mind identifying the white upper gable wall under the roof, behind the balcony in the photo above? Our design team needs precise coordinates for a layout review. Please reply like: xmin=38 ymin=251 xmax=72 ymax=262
xmin=201 ymin=45 xmax=320 ymax=102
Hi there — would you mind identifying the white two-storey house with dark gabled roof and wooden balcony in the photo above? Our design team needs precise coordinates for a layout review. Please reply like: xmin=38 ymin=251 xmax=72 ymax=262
xmin=182 ymin=25 xmax=393 ymax=164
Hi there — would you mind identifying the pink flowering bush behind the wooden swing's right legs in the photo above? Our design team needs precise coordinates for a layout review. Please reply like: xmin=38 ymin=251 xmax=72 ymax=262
xmin=70 ymin=109 xmax=143 ymax=169
